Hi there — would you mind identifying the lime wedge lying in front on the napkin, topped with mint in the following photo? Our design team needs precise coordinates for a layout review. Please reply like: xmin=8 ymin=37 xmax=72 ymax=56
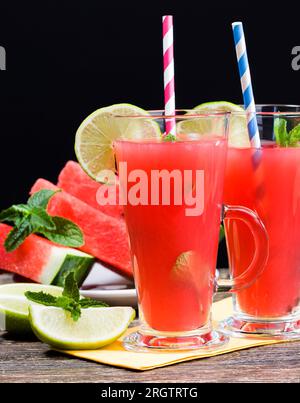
xmin=29 ymin=304 xmax=135 ymax=350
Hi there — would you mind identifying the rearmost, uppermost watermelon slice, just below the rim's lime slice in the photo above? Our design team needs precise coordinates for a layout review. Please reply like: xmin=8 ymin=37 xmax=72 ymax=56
xmin=57 ymin=161 xmax=124 ymax=218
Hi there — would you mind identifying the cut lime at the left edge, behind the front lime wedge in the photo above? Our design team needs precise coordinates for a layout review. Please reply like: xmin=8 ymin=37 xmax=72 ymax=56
xmin=0 ymin=283 xmax=62 ymax=336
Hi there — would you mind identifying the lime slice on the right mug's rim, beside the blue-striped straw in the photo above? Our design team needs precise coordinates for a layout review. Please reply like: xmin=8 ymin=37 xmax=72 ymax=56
xmin=176 ymin=101 xmax=250 ymax=147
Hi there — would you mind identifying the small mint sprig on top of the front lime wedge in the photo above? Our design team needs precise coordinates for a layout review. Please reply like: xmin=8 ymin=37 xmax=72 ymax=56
xmin=25 ymin=272 xmax=108 ymax=322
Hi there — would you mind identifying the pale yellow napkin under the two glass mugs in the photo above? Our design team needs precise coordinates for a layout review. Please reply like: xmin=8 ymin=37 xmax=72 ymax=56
xmin=60 ymin=298 xmax=280 ymax=371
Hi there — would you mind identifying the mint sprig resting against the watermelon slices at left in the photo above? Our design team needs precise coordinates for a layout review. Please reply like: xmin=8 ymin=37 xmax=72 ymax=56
xmin=0 ymin=189 xmax=84 ymax=252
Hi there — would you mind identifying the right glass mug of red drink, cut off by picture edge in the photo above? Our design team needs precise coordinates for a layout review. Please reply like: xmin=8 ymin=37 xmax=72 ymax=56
xmin=220 ymin=105 xmax=300 ymax=339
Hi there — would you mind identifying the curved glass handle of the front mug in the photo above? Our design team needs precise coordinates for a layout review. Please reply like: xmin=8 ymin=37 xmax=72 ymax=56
xmin=217 ymin=205 xmax=269 ymax=292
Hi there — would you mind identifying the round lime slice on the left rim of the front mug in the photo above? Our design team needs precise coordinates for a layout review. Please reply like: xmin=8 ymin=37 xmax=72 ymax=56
xmin=75 ymin=104 xmax=161 ymax=182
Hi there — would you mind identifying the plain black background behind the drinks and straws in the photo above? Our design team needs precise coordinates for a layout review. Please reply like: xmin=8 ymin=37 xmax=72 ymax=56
xmin=0 ymin=0 xmax=300 ymax=266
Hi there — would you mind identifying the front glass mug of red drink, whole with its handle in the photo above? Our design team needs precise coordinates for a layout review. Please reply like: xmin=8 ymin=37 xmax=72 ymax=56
xmin=114 ymin=110 xmax=268 ymax=351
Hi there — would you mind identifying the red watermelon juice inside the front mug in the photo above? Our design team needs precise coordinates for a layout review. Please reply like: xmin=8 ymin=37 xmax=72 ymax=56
xmin=115 ymin=136 xmax=227 ymax=332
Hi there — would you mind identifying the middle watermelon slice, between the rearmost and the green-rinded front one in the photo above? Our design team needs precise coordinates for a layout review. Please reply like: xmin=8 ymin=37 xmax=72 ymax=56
xmin=31 ymin=179 xmax=132 ymax=276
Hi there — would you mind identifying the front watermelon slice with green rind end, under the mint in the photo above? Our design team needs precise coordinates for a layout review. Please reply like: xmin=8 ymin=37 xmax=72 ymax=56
xmin=0 ymin=224 xmax=95 ymax=285
